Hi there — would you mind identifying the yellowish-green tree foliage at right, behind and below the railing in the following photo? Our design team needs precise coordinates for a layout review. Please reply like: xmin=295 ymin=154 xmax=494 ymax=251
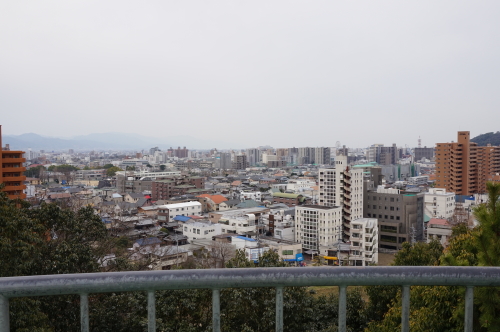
xmin=366 ymin=182 xmax=500 ymax=332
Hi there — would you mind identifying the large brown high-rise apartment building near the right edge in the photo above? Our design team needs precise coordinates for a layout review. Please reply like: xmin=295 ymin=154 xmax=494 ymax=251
xmin=436 ymin=131 xmax=500 ymax=195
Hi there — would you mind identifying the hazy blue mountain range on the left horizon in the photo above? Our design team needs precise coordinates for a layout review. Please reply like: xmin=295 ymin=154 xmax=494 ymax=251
xmin=2 ymin=133 xmax=235 ymax=151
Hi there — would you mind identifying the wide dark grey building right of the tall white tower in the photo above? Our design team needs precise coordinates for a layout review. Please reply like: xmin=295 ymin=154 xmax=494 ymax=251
xmin=363 ymin=186 xmax=424 ymax=249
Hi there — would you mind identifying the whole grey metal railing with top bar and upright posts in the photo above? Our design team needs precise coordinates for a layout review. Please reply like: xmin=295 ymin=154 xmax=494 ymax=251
xmin=0 ymin=266 xmax=500 ymax=332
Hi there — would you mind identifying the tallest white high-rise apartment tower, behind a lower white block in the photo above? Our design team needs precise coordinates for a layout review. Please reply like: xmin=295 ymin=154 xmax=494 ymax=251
xmin=318 ymin=156 xmax=363 ymax=241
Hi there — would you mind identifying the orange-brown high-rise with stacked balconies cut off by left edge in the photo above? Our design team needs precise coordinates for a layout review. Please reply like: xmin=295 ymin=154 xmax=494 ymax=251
xmin=0 ymin=125 xmax=26 ymax=199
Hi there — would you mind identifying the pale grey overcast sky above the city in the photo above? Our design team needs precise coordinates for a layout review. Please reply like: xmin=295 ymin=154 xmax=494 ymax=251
xmin=0 ymin=0 xmax=500 ymax=147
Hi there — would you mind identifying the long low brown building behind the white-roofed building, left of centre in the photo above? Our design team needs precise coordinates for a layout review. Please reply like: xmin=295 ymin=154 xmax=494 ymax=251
xmin=151 ymin=176 xmax=211 ymax=201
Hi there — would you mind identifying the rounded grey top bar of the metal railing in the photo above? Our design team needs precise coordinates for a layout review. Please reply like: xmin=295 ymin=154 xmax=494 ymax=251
xmin=0 ymin=266 xmax=500 ymax=297
